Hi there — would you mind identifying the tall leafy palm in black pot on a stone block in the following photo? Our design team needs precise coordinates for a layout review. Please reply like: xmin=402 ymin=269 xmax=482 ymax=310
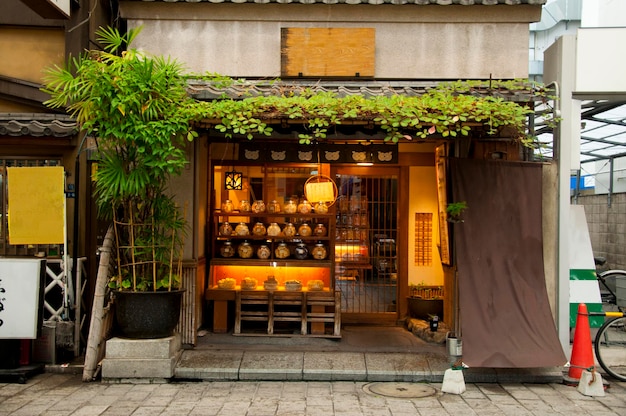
xmin=44 ymin=28 xmax=196 ymax=338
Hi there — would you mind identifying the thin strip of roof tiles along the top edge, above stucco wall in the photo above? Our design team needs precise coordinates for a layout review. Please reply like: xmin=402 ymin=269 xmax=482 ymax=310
xmin=131 ymin=0 xmax=547 ymax=6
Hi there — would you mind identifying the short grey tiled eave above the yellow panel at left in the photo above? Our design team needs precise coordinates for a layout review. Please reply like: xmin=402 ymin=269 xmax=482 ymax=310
xmin=0 ymin=113 xmax=78 ymax=137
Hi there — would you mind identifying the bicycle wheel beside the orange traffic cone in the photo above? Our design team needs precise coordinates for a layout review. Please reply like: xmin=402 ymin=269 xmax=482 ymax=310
xmin=594 ymin=316 xmax=626 ymax=381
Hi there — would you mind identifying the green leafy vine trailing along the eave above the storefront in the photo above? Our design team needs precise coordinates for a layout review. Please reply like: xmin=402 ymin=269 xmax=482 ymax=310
xmin=191 ymin=80 xmax=556 ymax=146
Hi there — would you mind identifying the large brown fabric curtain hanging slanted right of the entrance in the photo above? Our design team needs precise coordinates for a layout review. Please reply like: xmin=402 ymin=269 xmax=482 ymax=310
xmin=450 ymin=159 xmax=567 ymax=368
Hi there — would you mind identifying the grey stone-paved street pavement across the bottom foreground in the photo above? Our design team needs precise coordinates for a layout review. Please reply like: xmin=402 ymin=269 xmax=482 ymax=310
xmin=0 ymin=373 xmax=626 ymax=416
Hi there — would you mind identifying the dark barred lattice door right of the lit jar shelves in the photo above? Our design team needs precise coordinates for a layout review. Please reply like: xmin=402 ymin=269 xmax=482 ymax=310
xmin=334 ymin=167 xmax=398 ymax=324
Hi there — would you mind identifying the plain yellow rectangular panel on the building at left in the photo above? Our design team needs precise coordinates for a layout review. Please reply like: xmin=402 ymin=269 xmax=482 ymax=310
xmin=7 ymin=167 xmax=65 ymax=244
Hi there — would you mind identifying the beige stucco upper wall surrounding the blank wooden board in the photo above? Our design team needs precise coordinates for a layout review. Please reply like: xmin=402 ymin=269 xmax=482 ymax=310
xmin=121 ymin=2 xmax=541 ymax=79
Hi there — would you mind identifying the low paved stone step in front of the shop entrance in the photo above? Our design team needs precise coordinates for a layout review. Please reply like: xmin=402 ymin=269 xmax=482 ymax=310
xmin=168 ymin=326 xmax=563 ymax=383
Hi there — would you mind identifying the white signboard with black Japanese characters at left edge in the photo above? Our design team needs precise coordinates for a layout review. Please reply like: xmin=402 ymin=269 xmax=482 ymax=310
xmin=0 ymin=258 xmax=45 ymax=339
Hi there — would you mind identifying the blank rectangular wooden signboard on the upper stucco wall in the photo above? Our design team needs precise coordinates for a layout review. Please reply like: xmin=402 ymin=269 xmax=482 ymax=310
xmin=281 ymin=27 xmax=376 ymax=77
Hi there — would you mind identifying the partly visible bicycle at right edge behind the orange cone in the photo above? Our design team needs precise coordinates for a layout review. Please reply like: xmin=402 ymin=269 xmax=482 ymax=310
xmin=589 ymin=257 xmax=626 ymax=381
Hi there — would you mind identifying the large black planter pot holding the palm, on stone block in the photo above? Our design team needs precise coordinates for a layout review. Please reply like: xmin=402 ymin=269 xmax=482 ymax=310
xmin=115 ymin=290 xmax=184 ymax=339
